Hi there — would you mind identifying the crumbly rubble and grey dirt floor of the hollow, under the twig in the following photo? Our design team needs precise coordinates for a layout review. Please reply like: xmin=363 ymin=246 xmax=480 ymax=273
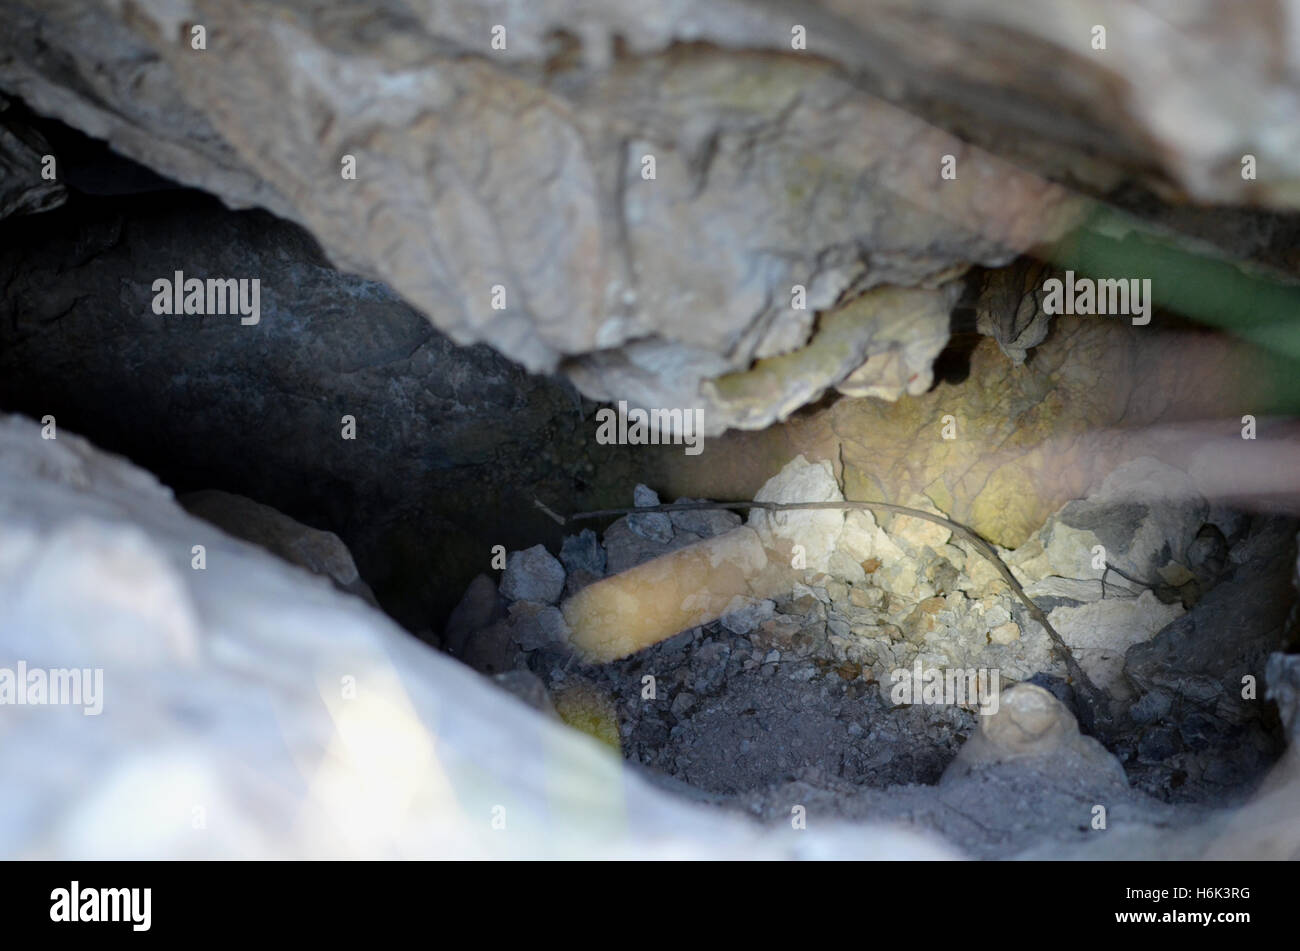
xmin=457 ymin=459 xmax=1294 ymax=857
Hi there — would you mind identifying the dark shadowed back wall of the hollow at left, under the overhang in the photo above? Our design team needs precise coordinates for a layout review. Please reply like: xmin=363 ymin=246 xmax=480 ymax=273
xmin=0 ymin=188 xmax=644 ymax=631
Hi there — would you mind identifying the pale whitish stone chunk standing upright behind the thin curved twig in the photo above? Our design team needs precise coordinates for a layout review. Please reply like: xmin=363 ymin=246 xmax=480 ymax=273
xmin=749 ymin=455 xmax=844 ymax=572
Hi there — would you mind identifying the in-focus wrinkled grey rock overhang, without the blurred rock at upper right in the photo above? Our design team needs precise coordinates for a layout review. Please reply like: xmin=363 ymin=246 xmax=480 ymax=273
xmin=0 ymin=0 xmax=1107 ymax=433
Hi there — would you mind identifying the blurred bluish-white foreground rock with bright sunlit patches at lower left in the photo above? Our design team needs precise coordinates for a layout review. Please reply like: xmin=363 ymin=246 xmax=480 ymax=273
xmin=0 ymin=417 xmax=954 ymax=860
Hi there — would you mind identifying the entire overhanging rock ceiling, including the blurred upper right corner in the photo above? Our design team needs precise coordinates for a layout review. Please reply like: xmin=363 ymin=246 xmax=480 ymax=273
xmin=0 ymin=0 xmax=1300 ymax=434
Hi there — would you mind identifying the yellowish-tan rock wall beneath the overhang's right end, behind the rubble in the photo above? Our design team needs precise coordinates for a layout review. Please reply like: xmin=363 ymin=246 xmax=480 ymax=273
xmin=826 ymin=317 xmax=1286 ymax=553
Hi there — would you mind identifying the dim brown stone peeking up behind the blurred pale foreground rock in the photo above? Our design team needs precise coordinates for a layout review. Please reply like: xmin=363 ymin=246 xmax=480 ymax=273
xmin=179 ymin=490 xmax=378 ymax=607
